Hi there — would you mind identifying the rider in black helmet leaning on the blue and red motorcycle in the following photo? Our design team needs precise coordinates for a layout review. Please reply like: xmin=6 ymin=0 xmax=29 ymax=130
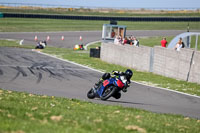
xmin=94 ymin=69 xmax=133 ymax=99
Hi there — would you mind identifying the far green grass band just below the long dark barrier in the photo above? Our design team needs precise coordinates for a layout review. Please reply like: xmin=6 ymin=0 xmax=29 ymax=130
xmin=0 ymin=18 xmax=200 ymax=32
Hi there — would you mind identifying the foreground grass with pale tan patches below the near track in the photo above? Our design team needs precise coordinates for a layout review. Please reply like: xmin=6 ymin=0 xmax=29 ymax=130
xmin=0 ymin=89 xmax=200 ymax=133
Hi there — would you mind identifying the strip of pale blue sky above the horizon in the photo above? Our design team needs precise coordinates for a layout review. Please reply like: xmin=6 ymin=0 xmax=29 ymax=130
xmin=0 ymin=0 xmax=200 ymax=9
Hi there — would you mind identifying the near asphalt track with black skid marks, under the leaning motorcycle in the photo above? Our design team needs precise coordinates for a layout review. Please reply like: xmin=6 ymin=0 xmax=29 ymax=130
xmin=0 ymin=32 xmax=200 ymax=119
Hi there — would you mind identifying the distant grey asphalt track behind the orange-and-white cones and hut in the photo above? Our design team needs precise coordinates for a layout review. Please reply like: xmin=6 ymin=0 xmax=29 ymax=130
xmin=0 ymin=30 xmax=196 ymax=48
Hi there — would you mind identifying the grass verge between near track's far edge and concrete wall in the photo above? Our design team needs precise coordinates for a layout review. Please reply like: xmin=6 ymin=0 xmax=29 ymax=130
xmin=0 ymin=40 xmax=200 ymax=96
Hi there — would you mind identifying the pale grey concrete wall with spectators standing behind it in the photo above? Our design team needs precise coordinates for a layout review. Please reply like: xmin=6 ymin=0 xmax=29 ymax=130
xmin=101 ymin=43 xmax=200 ymax=83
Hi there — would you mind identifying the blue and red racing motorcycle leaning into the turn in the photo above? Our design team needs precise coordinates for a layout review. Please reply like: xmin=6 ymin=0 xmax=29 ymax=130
xmin=87 ymin=77 xmax=125 ymax=100
